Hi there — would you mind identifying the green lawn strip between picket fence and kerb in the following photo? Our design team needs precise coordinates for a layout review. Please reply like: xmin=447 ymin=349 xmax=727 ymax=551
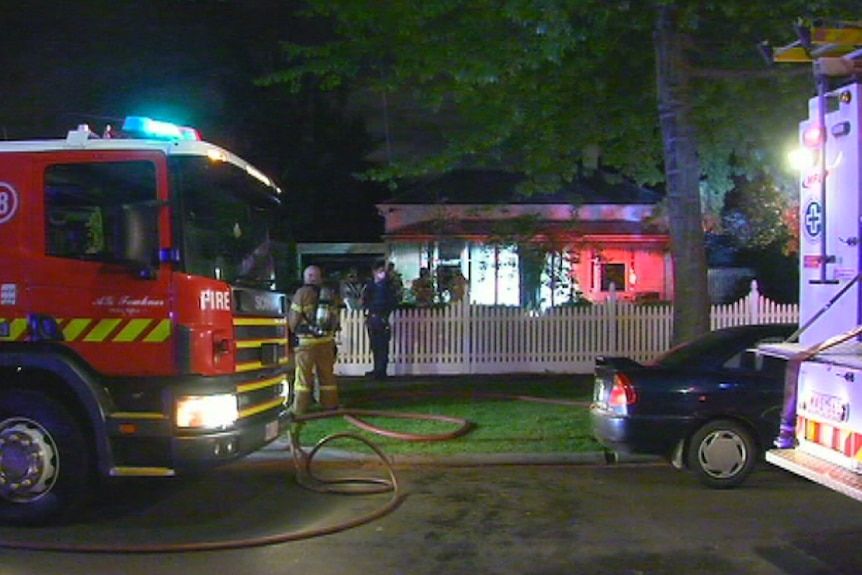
xmin=300 ymin=375 xmax=601 ymax=455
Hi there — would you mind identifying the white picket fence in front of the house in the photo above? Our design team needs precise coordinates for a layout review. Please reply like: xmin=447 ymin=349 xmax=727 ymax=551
xmin=336 ymin=282 xmax=799 ymax=375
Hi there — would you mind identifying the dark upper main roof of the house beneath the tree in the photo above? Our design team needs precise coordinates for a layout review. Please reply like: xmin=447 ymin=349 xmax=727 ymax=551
xmin=382 ymin=169 xmax=662 ymax=205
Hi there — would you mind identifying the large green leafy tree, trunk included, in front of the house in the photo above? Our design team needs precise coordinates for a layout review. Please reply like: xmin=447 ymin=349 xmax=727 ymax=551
xmin=266 ymin=0 xmax=858 ymax=339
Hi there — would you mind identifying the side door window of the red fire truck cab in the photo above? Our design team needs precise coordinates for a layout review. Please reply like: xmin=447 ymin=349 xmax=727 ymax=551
xmin=44 ymin=161 xmax=156 ymax=261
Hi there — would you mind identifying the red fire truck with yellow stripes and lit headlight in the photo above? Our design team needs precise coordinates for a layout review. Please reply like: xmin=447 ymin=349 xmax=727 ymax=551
xmin=0 ymin=117 xmax=292 ymax=524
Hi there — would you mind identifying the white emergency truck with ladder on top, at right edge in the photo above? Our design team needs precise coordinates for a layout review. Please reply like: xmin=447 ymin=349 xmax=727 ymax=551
xmin=763 ymin=22 xmax=862 ymax=501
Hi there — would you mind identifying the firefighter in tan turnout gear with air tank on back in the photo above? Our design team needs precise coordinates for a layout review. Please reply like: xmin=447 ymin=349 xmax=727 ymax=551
xmin=288 ymin=266 xmax=339 ymax=415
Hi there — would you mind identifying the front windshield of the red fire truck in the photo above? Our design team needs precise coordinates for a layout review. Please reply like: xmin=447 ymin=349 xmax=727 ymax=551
xmin=171 ymin=156 xmax=279 ymax=288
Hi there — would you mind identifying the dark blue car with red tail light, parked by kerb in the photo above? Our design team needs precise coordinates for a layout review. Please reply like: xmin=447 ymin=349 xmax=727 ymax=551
xmin=590 ymin=324 xmax=797 ymax=488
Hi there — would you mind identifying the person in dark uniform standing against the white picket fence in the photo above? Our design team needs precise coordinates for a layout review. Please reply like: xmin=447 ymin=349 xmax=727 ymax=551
xmin=362 ymin=260 xmax=398 ymax=379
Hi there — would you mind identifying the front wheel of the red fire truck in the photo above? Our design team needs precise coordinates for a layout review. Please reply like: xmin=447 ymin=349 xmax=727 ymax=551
xmin=0 ymin=390 xmax=92 ymax=525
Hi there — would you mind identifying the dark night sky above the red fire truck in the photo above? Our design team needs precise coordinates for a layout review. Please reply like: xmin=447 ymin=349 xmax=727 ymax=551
xmin=0 ymin=0 xmax=388 ymax=241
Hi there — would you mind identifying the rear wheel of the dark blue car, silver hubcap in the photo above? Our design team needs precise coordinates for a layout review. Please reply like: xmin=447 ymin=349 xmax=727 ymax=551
xmin=688 ymin=420 xmax=757 ymax=489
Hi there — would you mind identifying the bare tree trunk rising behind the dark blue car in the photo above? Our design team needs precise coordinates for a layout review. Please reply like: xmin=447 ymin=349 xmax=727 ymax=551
xmin=655 ymin=4 xmax=710 ymax=343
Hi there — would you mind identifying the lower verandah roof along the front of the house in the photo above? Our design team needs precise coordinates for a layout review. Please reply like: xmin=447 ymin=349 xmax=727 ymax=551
xmin=386 ymin=219 xmax=668 ymax=242
